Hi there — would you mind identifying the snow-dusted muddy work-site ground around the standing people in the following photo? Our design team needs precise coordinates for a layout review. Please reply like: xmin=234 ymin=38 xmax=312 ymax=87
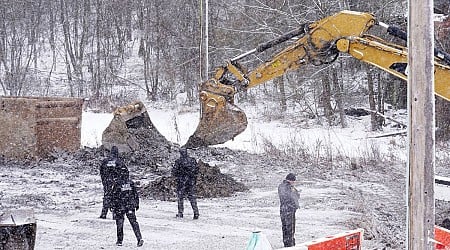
xmin=0 ymin=104 xmax=450 ymax=250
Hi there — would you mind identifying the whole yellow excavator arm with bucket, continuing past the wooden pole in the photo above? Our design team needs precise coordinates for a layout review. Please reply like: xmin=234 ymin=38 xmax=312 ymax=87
xmin=185 ymin=11 xmax=450 ymax=148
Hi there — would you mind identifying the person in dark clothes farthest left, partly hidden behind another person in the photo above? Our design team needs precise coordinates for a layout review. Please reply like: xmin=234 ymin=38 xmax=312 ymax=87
xmin=100 ymin=146 xmax=126 ymax=219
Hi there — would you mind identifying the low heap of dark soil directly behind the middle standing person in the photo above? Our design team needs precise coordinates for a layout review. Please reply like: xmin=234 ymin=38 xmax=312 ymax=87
xmin=140 ymin=160 xmax=248 ymax=200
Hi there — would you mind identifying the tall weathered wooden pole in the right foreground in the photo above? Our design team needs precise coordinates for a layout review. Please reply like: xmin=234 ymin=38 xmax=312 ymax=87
xmin=407 ymin=0 xmax=435 ymax=250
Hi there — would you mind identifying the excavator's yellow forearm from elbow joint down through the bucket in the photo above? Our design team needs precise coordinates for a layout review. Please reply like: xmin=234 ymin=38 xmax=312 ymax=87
xmin=185 ymin=11 xmax=375 ymax=148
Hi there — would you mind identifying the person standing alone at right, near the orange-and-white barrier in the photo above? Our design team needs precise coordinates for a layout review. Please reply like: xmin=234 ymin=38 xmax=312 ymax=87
xmin=278 ymin=173 xmax=300 ymax=247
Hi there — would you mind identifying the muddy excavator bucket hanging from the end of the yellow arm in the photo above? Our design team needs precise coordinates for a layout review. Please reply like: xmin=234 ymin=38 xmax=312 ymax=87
xmin=185 ymin=88 xmax=247 ymax=148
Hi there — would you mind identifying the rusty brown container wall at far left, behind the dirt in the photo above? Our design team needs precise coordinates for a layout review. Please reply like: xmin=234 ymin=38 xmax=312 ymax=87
xmin=0 ymin=97 xmax=83 ymax=159
